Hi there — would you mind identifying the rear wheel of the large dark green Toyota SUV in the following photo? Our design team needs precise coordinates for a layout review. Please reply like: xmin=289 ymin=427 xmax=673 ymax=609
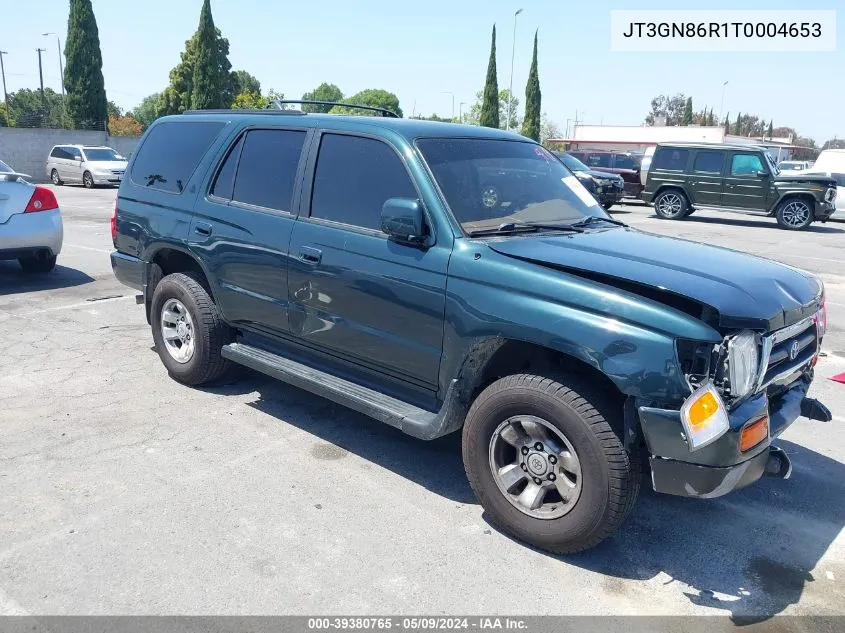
xmin=150 ymin=272 xmax=233 ymax=386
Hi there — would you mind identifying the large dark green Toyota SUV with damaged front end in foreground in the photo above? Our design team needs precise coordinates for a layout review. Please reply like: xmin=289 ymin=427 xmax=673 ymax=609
xmin=111 ymin=103 xmax=830 ymax=552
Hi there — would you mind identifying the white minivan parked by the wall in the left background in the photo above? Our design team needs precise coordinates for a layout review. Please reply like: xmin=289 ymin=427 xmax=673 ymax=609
xmin=46 ymin=145 xmax=126 ymax=189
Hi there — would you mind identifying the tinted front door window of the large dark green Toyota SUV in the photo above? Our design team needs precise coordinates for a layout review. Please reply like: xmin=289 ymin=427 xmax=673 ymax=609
xmin=311 ymin=134 xmax=418 ymax=230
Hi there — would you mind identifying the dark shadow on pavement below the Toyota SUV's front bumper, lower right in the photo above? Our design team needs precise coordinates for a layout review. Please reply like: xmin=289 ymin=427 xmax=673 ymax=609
xmin=528 ymin=441 xmax=845 ymax=624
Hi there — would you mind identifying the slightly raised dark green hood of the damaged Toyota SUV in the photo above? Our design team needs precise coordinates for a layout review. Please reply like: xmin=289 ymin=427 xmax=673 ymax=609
xmin=488 ymin=228 xmax=822 ymax=331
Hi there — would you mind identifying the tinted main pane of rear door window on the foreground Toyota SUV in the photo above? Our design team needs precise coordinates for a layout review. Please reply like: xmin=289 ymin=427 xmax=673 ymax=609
xmin=231 ymin=130 xmax=305 ymax=212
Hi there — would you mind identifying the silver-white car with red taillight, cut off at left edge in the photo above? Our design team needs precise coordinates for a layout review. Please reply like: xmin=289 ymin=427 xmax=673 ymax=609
xmin=0 ymin=161 xmax=64 ymax=273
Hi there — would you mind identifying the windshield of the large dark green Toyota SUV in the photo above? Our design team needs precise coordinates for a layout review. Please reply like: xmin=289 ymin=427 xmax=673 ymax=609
xmin=417 ymin=138 xmax=608 ymax=232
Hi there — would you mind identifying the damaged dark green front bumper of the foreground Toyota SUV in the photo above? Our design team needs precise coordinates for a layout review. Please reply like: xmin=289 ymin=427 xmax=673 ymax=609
xmin=639 ymin=373 xmax=832 ymax=499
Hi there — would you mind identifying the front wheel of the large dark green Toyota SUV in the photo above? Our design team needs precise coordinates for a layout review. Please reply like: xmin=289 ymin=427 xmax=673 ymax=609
xmin=463 ymin=374 xmax=641 ymax=554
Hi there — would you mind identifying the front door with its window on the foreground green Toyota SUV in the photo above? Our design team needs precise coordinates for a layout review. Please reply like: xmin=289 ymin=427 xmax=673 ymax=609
xmin=288 ymin=132 xmax=451 ymax=394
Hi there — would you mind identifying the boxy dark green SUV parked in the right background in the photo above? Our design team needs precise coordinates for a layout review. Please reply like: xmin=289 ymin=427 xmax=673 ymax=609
xmin=641 ymin=143 xmax=836 ymax=231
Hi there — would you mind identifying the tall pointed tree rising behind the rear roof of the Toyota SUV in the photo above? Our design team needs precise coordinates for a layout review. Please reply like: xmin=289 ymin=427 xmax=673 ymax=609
xmin=156 ymin=0 xmax=236 ymax=116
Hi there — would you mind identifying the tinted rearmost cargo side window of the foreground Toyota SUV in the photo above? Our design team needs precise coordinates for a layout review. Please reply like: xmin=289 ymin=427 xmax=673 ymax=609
xmin=130 ymin=121 xmax=226 ymax=193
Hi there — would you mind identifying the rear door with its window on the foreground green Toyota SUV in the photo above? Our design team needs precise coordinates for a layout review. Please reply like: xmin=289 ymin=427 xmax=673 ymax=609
xmin=189 ymin=128 xmax=308 ymax=335
